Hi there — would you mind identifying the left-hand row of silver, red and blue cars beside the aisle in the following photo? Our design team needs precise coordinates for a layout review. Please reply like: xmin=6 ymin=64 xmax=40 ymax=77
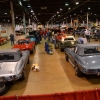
xmin=0 ymin=35 xmax=36 ymax=95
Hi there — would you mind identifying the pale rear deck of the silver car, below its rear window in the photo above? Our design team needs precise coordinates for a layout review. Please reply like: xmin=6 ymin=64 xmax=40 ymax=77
xmin=0 ymin=62 xmax=17 ymax=77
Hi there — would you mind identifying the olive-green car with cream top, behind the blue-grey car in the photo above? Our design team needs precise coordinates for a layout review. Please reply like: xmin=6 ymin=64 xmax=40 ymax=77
xmin=57 ymin=36 xmax=78 ymax=51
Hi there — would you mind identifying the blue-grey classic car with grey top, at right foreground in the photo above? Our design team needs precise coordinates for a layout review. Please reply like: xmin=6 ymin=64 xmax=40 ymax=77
xmin=65 ymin=44 xmax=100 ymax=77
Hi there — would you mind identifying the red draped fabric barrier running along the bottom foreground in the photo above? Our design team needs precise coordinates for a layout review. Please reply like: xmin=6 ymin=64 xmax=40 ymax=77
xmin=0 ymin=89 xmax=100 ymax=100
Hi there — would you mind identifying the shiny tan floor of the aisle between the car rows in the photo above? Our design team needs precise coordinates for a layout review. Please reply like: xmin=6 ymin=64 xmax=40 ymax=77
xmin=0 ymin=36 xmax=100 ymax=96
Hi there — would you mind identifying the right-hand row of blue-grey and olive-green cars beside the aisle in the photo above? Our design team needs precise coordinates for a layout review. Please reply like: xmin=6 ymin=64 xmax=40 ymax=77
xmin=56 ymin=33 xmax=100 ymax=77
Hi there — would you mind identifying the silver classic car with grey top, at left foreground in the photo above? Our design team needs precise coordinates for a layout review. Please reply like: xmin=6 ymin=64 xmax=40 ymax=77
xmin=0 ymin=49 xmax=30 ymax=95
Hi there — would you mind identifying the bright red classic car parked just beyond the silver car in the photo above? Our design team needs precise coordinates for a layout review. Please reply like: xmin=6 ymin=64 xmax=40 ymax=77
xmin=12 ymin=39 xmax=35 ymax=54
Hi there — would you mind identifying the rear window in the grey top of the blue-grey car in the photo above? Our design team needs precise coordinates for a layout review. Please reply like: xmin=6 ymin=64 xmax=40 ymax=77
xmin=84 ymin=47 xmax=100 ymax=54
